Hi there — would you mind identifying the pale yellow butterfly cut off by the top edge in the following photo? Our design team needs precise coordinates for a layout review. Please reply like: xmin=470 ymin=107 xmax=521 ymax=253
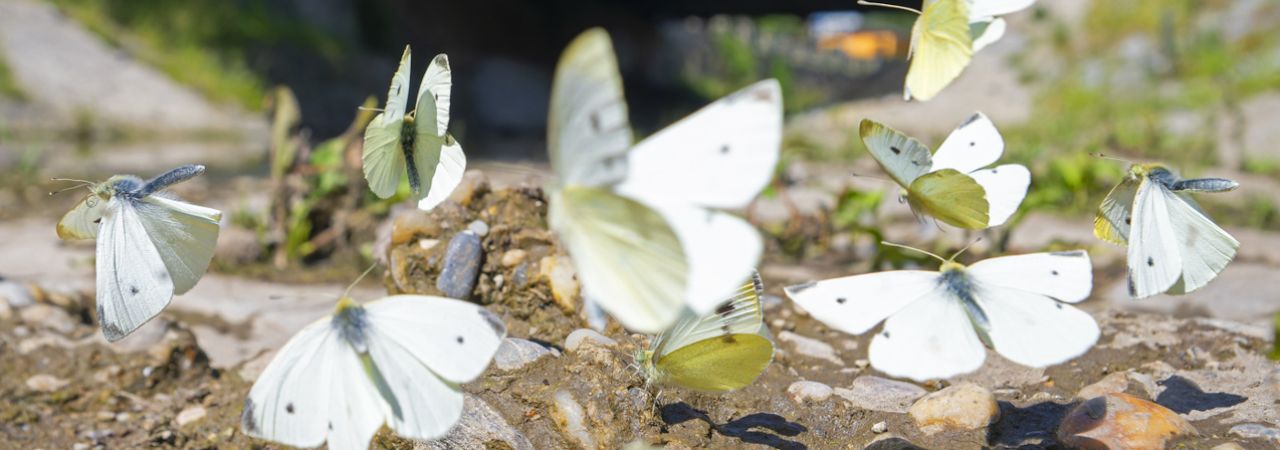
xmin=859 ymin=0 xmax=1034 ymax=101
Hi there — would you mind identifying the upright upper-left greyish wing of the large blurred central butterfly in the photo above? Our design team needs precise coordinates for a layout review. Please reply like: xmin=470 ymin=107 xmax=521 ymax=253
xmin=547 ymin=28 xmax=631 ymax=187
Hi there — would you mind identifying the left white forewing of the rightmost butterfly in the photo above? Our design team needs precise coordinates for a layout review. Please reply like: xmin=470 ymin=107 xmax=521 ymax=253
xmin=1126 ymin=178 xmax=1183 ymax=298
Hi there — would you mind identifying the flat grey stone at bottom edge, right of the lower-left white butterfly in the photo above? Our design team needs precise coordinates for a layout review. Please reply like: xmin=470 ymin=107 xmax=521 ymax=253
xmin=413 ymin=394 xmax=534 ymax=450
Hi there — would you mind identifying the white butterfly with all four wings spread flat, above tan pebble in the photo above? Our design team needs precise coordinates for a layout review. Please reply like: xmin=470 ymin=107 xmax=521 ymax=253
xmin=785 ymin=244 xmax=1098 ymax=381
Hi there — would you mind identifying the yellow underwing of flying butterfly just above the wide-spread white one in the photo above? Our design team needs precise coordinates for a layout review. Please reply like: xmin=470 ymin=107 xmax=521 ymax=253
xmin=906 ymin=169 xmax=989 ymax=230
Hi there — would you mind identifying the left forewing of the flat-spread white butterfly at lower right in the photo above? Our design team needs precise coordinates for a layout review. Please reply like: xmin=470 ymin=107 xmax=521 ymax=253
xmin=783 ymin=270 xmax=938 ymax=335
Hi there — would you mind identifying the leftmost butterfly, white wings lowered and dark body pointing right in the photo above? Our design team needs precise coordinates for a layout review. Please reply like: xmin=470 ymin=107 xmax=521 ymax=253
xmin=58 ymin=165 xmax=223 ymax=341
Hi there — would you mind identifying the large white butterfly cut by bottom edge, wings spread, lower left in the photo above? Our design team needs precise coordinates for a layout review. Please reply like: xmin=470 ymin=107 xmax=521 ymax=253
xmin=241 ymin=295 xmax=507 ymax=450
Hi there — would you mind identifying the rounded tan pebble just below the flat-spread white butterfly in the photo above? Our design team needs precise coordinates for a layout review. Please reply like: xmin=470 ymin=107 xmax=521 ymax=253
xmin=908 ymin=382 xmax=1000 ymax=435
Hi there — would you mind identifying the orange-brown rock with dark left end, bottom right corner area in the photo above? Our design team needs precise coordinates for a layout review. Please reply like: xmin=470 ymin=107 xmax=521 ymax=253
xmin=1057 ymin=394 xmax=1196 ymax=449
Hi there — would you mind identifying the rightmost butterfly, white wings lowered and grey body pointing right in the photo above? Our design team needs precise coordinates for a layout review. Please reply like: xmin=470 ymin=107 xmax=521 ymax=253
xmin=1093 ymin=164 xmax=1240 ymax=298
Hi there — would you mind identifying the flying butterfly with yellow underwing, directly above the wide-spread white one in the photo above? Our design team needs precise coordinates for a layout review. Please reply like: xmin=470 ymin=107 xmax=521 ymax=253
xmin=858 ymin=113 xmax=1032 ymax=230
